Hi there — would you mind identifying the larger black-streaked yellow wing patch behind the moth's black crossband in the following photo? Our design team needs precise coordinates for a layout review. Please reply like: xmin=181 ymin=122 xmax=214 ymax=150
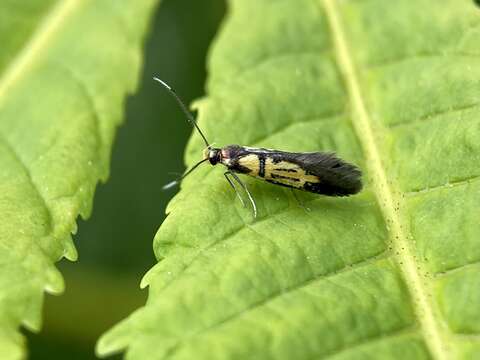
xmin=265 ymin=158 xmax=319 ymax=188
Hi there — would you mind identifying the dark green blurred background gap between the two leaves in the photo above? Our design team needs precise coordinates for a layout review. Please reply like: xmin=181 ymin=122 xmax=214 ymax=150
xmin=26 ymin=0 xmax=225 ymax=359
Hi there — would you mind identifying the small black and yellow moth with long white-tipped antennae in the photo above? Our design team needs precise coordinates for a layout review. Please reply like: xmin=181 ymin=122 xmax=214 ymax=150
xmin=154 ymin=77 xmax=362 ymax=217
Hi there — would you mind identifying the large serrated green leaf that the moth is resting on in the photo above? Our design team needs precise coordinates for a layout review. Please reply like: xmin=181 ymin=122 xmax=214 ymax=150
xmin=97 ymin=0 xmax=480 ymax=359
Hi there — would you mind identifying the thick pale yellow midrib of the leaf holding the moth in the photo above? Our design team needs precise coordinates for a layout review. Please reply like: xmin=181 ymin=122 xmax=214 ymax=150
xmin=322 ymin=0 xmax=449 ymax=360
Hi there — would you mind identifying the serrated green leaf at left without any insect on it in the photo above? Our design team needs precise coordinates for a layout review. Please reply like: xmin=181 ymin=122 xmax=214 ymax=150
xmin=0 ymin=0 xmax=156 ymax=359
